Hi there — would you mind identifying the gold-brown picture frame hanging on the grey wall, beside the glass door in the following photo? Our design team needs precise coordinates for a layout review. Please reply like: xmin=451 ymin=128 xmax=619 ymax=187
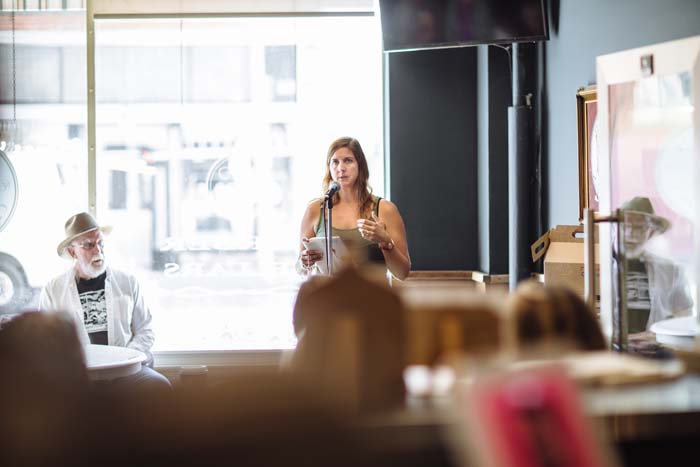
xmin=576 ymin=85 xmax=599 ymax=222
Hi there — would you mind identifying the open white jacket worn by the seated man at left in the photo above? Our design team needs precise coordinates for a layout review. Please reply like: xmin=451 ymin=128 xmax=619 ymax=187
xmin=39 ymin=268 xmax=155 ymax=361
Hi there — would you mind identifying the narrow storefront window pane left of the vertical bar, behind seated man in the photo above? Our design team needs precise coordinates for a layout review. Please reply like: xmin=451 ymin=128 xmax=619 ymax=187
xmin=0 ymin=8 xmax=88 ymax=319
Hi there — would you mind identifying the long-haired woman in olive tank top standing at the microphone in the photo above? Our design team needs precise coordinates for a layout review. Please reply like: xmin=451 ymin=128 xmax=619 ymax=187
xmin=299 ymin=137 xmax=411 ymax=280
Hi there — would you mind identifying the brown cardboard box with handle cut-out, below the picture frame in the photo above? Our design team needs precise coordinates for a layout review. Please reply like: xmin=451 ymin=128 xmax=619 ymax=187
xmin=531 ymin=225 xmax=600 ymax=300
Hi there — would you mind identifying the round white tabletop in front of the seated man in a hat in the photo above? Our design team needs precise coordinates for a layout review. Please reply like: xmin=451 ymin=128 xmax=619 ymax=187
xmin=83 ymin=344 xmax=146 ymax=381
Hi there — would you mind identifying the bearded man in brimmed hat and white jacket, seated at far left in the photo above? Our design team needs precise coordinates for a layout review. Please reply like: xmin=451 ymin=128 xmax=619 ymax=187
xmin=39 ymin=212 xmax=170 ymax=387
